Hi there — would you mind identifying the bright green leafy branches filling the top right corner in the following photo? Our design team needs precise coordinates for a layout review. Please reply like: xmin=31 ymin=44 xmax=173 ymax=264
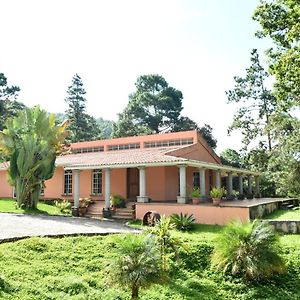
xmin=253 ymin=0 xmax=300 ymax=111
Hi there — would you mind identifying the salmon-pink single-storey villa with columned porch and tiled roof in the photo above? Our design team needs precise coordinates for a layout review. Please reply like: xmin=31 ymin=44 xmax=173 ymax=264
xmin=0 ymin=131 xmax=290 ymax=224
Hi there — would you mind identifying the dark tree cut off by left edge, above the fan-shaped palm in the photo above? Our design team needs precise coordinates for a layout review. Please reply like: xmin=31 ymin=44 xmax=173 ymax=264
xmin=0 ymin=73 xmax=25 ymax=130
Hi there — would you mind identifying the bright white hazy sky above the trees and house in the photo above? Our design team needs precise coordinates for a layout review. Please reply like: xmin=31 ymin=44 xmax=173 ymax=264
xmin=0 ymin=0 xmax=268 ymax=152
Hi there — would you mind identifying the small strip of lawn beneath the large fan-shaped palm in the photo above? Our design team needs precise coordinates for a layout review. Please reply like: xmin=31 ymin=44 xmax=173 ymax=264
xmin=0 ymin=199 xmax=68 ymax=215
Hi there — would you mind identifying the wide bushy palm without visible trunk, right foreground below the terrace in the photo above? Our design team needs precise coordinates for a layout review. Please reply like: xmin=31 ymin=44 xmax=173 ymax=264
xmin=212 ymin=220 xmax=285 ymax=280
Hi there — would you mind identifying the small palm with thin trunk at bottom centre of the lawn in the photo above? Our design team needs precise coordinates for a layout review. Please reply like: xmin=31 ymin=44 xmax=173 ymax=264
xmin=110 ymin=234 xmax=162 ymax=299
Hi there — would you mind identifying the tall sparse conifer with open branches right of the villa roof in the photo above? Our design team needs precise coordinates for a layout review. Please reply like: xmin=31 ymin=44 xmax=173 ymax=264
xmin=226 ymin=49 xmax=276 ymax=150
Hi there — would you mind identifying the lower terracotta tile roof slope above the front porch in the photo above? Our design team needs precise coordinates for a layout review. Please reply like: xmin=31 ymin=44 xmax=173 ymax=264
xmin=56 ymin=147 xmax=187 ymax=168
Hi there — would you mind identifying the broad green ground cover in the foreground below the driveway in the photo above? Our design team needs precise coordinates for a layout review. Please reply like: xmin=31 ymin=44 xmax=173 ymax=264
xmin=0 ymin=225 xmax=300 ymax=300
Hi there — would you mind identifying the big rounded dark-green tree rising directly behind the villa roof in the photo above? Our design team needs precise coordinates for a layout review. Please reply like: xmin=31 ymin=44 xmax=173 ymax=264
xmin=113 ymin=74 xmax=217 ymax=149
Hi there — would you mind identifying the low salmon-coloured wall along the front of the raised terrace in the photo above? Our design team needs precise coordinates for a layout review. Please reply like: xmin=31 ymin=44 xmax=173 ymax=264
xmin=136 ymin=203 xmax=249 ymax=225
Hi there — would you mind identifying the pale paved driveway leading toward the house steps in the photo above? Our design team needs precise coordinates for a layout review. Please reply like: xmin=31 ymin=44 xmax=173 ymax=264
xmin=0 ymin=213 xmax=136 ymax=242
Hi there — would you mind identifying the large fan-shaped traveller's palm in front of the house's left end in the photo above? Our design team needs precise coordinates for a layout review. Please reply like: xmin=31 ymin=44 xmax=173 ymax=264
xmin=0 ymin=107 xmax=67 ymax=208
